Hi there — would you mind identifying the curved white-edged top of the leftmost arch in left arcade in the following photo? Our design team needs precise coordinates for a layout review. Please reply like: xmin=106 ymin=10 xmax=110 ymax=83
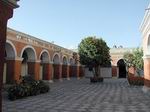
xmin=5 ymin=40 xmax=17 ymax=58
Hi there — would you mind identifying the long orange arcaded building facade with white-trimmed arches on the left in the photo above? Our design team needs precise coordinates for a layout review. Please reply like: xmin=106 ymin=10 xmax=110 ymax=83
xmin=3 ymin=28 xmax=83 ymax=83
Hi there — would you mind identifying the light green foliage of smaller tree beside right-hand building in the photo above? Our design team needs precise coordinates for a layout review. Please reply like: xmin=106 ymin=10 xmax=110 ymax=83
xmin=124 ymin=48 xmax=144 ymax=70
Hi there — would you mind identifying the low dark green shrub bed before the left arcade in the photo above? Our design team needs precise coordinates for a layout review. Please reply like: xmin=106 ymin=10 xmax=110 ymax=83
xmin=8 ymin=75 xmax=50 ymax=100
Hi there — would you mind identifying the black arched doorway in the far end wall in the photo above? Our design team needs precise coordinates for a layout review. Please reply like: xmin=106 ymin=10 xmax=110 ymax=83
xmin=117 ymin=59 xmax=127 ymax=78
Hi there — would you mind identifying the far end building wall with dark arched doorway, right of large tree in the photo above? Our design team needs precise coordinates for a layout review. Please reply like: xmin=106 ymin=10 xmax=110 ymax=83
xmin=110 ymin=47 xmax=135 ymax=78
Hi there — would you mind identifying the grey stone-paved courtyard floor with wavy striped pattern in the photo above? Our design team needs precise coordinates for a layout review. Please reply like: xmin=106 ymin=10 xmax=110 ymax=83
xmin=3 ymin=78 xmax=150 ymax=112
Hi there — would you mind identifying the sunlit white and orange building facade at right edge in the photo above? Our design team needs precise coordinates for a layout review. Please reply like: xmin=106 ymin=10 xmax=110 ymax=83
xmin=140 ymin=5 xmax=150 ymax=93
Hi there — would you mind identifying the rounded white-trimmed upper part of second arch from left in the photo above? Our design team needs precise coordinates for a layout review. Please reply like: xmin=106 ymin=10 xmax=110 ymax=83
xmin=20 ymin=45 xmax=37 ymax=61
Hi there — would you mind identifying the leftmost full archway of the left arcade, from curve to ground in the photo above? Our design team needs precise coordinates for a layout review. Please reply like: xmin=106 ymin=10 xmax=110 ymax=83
xmin=3 ymin=41 xmax=17 ymax=84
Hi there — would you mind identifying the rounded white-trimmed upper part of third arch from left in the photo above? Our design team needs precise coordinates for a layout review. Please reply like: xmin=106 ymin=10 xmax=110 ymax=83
xmin=39 ymin=49 xmax=50 ymax=62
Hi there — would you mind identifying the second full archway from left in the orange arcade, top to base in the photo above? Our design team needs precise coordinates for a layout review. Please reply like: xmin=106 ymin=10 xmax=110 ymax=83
xmin=21 ymin=46 xmax=36 ymax=77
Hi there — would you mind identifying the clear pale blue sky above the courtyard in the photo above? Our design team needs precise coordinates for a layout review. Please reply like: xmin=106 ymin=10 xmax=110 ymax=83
xmin=8 ymin=0 xmax=150 ymax=49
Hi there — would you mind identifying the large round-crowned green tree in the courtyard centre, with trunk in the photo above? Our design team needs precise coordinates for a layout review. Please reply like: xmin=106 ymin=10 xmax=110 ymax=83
xmin=78 ymin=36 xmax=111 ymax=77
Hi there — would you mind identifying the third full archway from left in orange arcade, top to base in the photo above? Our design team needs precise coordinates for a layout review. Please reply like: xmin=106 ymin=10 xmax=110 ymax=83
xmin=40 ymin=50 xmax=49 ymax=80
